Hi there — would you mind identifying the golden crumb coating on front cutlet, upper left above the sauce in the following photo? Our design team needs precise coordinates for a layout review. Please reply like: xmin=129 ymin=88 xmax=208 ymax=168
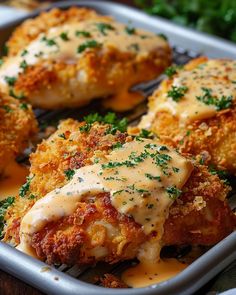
xmin=3 ymin=119 xmax=130 ymax=244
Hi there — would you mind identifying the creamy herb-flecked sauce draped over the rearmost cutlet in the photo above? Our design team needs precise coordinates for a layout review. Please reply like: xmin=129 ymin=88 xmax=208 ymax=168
xmin=0 ymin=18 xmax=166 ymax=92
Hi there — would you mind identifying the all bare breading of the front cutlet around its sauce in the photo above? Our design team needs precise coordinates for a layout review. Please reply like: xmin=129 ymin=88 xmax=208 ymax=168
xmin=5 ymin=119 xmax=236 ymax=264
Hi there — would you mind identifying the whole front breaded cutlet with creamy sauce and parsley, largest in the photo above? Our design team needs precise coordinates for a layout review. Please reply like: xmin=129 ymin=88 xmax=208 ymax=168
xmin=4 ymin=118 xmax=235 ymax=264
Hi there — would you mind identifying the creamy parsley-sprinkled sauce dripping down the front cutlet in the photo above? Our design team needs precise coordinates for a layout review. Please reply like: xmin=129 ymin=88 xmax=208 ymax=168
xmin=19 ymin=139 xmax=193 ymax=260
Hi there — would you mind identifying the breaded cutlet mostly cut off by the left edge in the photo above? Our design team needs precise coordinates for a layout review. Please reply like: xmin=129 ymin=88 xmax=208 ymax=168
xmin=0 ymin=93 xmax=37 ymax=173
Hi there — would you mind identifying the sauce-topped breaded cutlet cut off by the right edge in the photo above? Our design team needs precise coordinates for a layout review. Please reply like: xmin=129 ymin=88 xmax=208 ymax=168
xmin=139 ymin=57 xmax=236 ymax=174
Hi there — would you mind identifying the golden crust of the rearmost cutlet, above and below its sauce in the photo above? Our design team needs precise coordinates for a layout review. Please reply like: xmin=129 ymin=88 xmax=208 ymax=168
xmin=3 ymin=7 xmax=171 ymax=111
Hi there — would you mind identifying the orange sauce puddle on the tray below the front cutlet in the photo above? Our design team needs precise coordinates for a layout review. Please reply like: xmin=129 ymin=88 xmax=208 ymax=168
xmin=122 ymin=258 xmax=188 ymax=288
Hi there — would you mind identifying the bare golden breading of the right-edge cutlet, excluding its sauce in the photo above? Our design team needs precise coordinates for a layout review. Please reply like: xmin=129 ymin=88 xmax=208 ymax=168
xmin=139 ymin=57 xmax=236 ymax=174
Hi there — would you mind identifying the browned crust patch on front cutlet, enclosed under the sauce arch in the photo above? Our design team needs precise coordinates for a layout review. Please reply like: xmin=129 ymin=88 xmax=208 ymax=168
xmin=32 ymin=194 xmax=146 ymax=265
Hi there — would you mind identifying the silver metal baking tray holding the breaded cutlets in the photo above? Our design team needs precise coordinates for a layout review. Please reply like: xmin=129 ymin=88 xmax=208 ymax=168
xmin=0 ymin=0 xmax=236 ymax=295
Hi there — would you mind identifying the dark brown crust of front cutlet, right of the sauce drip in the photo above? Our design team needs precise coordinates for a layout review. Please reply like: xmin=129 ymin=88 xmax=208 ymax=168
xmin=163 ymin=166 xmax=236 ymax=245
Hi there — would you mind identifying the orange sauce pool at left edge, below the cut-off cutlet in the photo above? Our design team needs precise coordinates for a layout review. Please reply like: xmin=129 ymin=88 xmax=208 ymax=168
xmin=0 ymin=162 xmax=29 ymax=200
